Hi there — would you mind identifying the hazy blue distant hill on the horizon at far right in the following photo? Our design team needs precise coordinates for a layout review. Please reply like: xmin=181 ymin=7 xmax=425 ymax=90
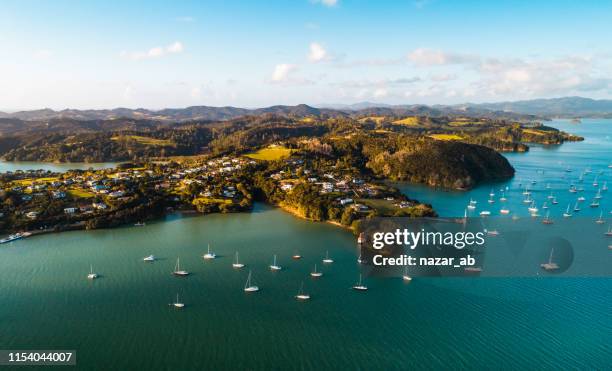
xmin=456 ymin=97 xmax=612 ymax=118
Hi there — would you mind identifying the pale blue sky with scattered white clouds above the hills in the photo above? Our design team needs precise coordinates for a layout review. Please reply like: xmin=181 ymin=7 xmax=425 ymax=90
xmin=0 ymin=0 xmax=612 ymax=111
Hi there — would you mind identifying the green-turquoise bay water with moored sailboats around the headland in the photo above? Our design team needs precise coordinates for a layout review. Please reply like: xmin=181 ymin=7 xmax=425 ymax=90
xmin=0 ymin=121 xmax=612 ymax=370
